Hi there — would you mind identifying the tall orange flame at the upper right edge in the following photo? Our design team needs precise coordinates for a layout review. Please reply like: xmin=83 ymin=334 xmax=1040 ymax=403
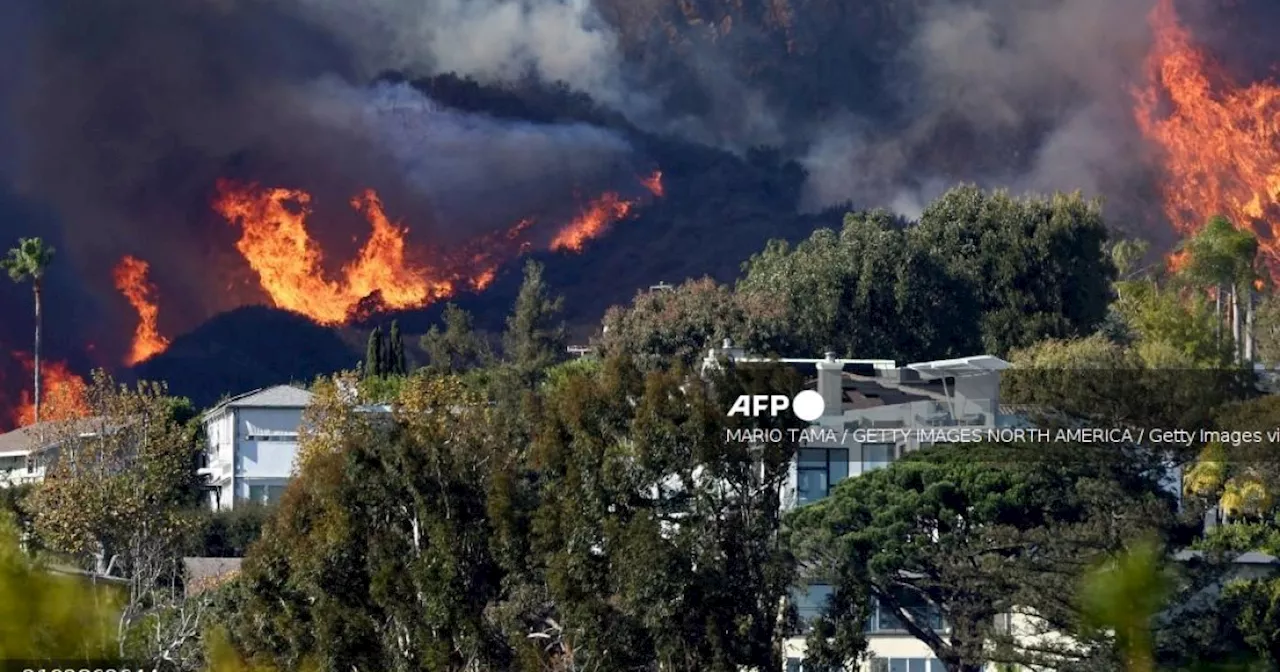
xmin=1134 ymin=0 xmax=1280 ymax=274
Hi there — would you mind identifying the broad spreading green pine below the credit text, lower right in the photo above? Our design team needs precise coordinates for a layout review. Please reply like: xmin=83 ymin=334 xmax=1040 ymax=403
xmin=788 ymin=443 xmax=1172 ymax=672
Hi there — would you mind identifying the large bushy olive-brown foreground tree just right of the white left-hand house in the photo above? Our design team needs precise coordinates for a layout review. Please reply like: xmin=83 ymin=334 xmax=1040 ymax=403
xmin=232 ymin=378 xmax=515 ymax=671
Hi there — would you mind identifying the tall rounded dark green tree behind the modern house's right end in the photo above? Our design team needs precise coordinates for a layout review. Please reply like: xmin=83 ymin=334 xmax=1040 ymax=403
xmin=910 ymin=186 xmax=1116 ymax=355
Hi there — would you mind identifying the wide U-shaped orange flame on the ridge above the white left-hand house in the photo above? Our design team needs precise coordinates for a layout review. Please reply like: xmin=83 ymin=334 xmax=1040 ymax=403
xmin=214 ymin=180 xmax=453 ymax=325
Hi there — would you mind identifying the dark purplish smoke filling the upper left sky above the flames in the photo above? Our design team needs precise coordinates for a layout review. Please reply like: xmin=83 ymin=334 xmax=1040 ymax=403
xmin=0 ymin=0 xmax=634 ymax=360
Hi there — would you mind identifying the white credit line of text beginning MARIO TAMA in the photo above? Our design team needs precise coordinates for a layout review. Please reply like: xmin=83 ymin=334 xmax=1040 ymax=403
xmin=724 ymin=426 xmax=1280 ymax=445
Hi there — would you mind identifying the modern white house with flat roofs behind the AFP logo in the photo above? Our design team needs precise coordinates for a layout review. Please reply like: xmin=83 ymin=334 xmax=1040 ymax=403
xmin=703 ymin=340 xmax=1023 ymax=672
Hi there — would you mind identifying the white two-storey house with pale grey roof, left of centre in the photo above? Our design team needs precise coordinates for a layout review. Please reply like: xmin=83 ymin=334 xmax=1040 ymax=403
xmin=198 ymin=385 xmax=311 ymax=511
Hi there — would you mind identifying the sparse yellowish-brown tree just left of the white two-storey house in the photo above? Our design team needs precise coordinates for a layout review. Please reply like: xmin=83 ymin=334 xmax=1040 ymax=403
xmin=23 ymin=371 xmax=198 ymax=652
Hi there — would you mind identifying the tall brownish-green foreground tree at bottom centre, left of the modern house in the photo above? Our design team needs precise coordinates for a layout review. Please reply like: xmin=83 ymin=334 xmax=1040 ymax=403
xmin=521 ymin=357 xmax=800 ymax=672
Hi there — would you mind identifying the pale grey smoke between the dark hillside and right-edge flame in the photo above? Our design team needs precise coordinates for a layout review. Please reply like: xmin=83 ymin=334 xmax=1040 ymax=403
xmin=804 ymin=0 xmax=1153 ymax=216
